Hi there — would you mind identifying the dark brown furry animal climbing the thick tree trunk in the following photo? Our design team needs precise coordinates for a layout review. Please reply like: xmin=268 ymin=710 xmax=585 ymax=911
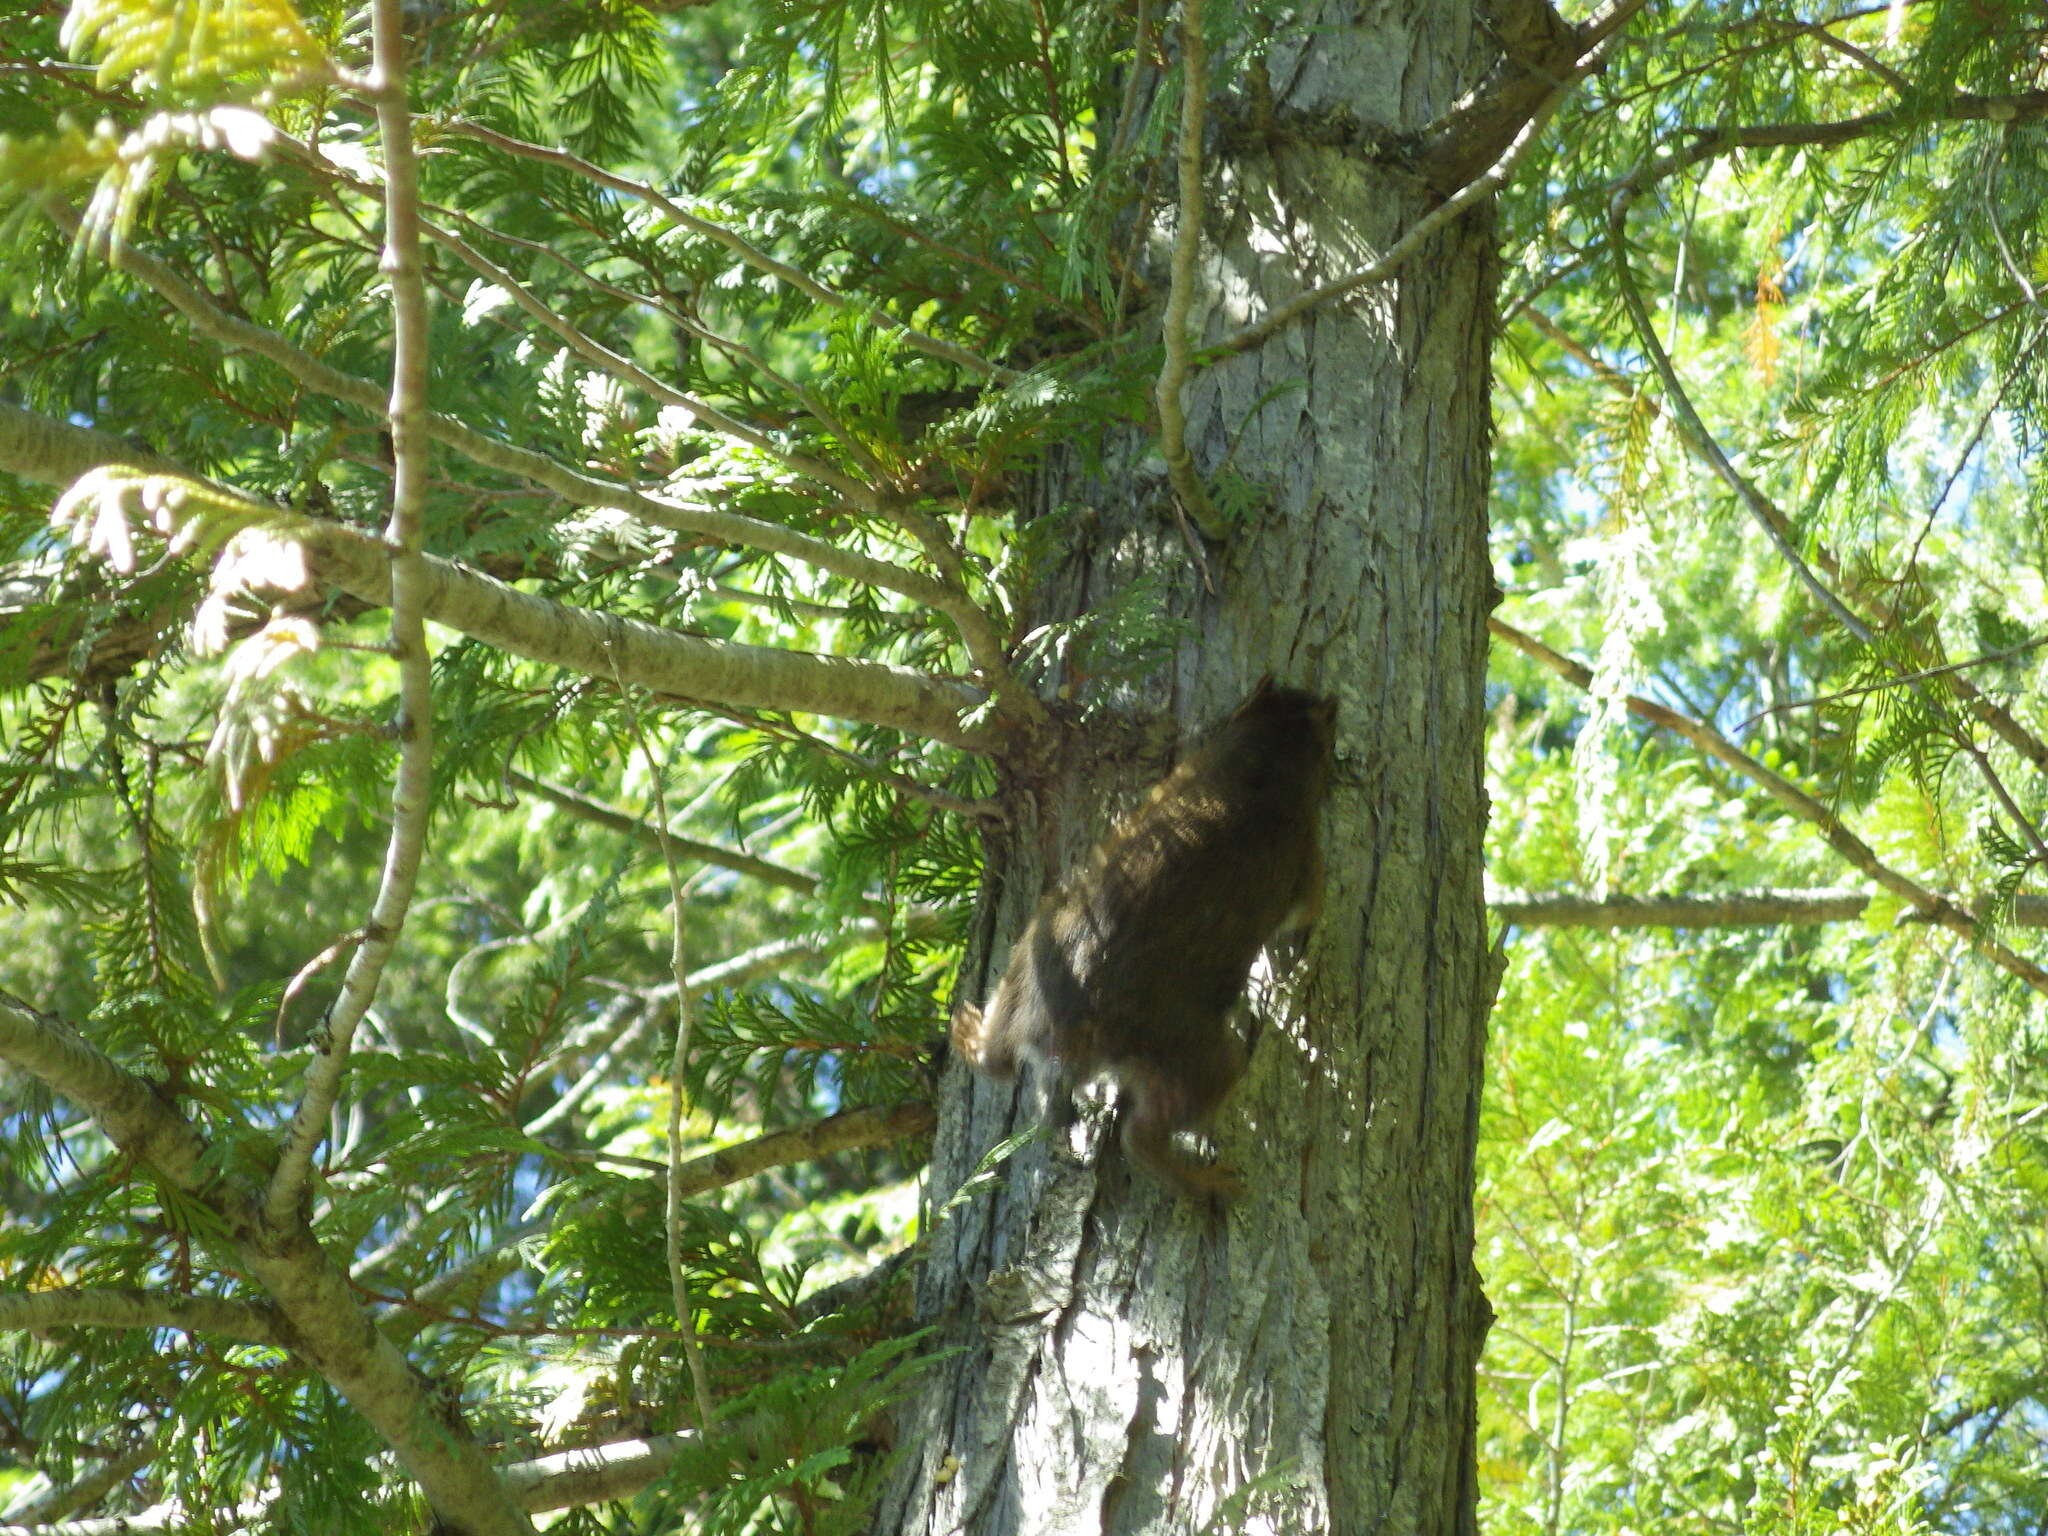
xmin=952 ymin=678 xmax=1337 ymax=1200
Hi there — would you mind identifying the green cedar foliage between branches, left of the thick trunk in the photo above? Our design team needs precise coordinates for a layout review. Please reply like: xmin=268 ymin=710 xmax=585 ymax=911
xmin=0 ymin=0 xmax=1105 ymax=1532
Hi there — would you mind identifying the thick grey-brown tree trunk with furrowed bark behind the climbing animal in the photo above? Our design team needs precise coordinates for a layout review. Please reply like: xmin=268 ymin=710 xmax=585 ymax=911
xmin=877 ymin=0 xmax=1495 ymax=1536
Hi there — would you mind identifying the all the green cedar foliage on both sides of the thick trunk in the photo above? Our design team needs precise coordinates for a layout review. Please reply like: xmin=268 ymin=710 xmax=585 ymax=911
xmin=0 ymin=0 xmax=2048 ymax=1534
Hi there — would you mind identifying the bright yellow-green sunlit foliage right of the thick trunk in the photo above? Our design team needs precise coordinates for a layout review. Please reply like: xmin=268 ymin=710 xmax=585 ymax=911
xmin=1479 ymin=4 xmax=2048 ymax=1536
